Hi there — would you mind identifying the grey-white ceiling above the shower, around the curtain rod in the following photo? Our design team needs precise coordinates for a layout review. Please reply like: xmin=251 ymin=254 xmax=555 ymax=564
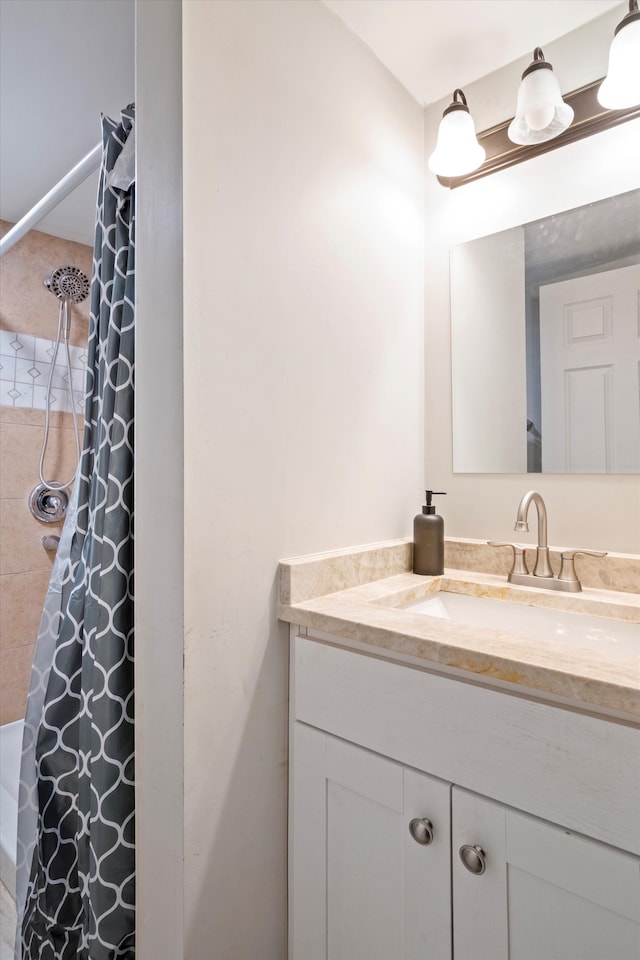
xmin=0 ymin=0 xmax=134 ymax=244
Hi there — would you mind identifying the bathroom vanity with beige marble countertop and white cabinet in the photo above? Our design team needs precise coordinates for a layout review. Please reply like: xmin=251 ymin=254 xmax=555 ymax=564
xmin=280 ymin=541 xmax=640 ymax=960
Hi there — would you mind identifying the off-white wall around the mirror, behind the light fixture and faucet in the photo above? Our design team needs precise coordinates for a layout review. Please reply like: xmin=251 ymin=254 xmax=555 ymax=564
xmin=425 ymin=8 xmax=640 ymax=553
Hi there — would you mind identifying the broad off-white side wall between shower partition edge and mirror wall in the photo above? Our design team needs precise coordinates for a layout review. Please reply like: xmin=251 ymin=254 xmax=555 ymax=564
xmin=183 ymin=0 xmax=424 ymax=960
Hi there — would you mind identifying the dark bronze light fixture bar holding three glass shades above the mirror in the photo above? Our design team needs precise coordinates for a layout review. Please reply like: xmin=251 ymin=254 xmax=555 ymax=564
xmin=438 ymin=80 xmax=640 ymax=190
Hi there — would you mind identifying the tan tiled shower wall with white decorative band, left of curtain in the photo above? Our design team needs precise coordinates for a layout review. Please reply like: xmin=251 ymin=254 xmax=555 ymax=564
xmin=0 ymin=221 xmax=92 ymax=723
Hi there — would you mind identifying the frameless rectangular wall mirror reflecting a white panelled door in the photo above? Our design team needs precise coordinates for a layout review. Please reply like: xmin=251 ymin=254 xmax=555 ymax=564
xmin=451 ymin=190 xmax=640 ymax=474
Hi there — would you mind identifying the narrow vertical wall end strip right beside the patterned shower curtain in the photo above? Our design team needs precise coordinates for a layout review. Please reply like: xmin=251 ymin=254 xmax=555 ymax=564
xmin=135 ymin=0 xmax=184 ymax=960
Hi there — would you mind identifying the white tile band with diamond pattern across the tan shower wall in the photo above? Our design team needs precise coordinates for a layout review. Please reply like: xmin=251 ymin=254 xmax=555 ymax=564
xmin=0 ymin=330 xmax=87 ymax=413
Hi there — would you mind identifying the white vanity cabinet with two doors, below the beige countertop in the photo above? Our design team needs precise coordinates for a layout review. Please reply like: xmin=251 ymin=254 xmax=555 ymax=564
xmin=289 ymin=637 xmax=640 ymax=960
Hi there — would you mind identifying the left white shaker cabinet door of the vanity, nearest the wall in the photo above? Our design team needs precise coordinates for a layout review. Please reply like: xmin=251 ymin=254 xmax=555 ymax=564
xmin=289 ymin=723 xmax=451 ymax=960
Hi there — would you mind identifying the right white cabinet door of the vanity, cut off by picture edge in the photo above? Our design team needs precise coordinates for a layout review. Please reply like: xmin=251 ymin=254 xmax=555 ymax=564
xmin=452 ymin=787 xmax=640 ymax=960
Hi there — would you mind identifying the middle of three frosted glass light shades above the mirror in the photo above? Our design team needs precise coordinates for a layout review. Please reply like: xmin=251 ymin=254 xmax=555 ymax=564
xmin=508 ymin=66 xmax=573 ymax=144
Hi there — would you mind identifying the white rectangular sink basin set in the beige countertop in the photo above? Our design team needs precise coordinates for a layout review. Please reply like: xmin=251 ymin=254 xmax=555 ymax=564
xmin=403 ymin=590 xmax=640 ymax=659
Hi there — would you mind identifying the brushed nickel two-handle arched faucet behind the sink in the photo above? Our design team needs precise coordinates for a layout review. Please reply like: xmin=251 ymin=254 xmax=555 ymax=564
xmin=488 ymin=490 xmax=607 ymax=593
